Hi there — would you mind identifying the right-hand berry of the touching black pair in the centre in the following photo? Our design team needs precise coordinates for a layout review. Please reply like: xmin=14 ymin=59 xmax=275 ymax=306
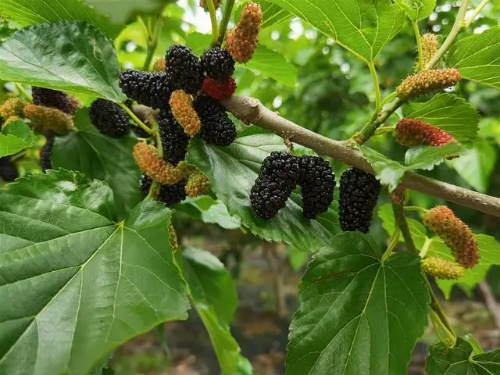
xmin=298 ymin=155 xmax=335 ymax=219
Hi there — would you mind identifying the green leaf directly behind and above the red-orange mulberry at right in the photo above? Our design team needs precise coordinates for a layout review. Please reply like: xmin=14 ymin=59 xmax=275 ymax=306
xmin=403 ymin=93 xmax=479 ymax=142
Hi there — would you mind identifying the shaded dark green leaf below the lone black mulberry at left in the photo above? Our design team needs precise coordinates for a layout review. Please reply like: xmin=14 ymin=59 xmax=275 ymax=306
xmin=52 ymin=109 xmax=143 ymax=218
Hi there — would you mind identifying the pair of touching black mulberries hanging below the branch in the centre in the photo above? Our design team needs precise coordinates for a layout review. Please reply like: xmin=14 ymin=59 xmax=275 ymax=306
xmin=250 ymin=152 xmax=335 ymax=219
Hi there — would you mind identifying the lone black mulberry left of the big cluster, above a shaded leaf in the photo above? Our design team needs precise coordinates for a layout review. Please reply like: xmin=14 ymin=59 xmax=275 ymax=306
xmin=89 ymin=99 xmax=129 ymax=138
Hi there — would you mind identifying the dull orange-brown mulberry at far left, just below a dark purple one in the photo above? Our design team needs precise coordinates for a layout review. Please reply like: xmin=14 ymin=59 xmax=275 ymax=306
xmin=24 ymin=104 xmax=75 ymax=134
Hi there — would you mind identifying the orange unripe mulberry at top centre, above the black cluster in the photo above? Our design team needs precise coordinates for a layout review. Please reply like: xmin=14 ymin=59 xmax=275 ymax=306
xmin=226 ymin=3 xmax=262 ymax=63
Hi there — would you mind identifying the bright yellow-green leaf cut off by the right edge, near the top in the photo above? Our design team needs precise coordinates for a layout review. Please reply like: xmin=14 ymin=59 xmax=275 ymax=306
xmin=448 ymin=26 xmax=500 ymax=89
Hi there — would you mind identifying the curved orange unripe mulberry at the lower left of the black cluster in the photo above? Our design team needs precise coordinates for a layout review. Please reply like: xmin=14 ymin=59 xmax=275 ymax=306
xmin=133 ymin=142 xmax=181 ymax=185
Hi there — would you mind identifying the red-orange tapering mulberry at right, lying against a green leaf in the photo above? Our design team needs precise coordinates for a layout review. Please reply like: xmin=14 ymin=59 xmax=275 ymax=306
xmin=394 ymin=118 xmax=456 ymax=147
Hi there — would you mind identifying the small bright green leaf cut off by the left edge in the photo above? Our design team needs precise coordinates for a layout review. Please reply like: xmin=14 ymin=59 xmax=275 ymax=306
xmin=0 ymin=120 xmax=36 ymax=157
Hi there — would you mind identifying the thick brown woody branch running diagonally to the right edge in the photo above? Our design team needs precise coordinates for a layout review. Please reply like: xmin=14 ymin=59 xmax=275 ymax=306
xmin=221 ymin=96 xmax=500 ymax=217
